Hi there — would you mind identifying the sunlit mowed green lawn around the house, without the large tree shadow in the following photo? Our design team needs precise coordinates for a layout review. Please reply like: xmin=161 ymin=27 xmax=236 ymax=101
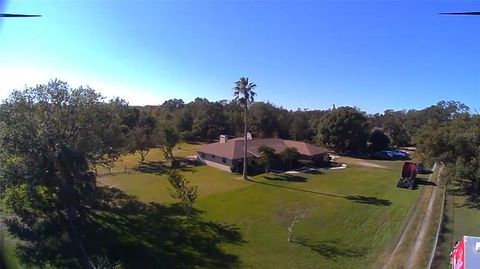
xmin=101 ymin=156 xmax=419 ymax=268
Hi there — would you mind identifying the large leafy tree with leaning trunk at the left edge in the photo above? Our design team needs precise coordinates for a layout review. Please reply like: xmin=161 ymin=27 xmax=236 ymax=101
xmin=0 ymin=80 xmax=130 ymax=268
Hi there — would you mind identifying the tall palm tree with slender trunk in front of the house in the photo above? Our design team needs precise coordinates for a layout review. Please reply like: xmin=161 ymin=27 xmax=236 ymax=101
xmin=233 ymin=77 xmax=257 ymax=179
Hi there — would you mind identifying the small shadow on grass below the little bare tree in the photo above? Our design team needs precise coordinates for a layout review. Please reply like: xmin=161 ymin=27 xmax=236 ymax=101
xmin=291 ymin=238 xmax=367 ymax=260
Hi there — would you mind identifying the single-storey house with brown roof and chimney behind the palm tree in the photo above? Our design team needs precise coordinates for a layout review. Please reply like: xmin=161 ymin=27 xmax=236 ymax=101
xmin=197 ymin=135 xmax=329 ymax=172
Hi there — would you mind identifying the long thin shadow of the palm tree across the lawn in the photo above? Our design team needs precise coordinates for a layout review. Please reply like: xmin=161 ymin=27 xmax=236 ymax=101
xmin=248 ymin=177 xmax=392 ymax=206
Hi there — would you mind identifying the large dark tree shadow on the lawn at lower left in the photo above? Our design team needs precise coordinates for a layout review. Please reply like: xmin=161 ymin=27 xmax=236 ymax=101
xmin=2 ymin=187 xmax=244 ymax=268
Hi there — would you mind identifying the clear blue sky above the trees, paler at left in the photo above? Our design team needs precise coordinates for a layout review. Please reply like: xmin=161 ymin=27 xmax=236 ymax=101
xmin=0 ymin=0 xmax=480 ymax=113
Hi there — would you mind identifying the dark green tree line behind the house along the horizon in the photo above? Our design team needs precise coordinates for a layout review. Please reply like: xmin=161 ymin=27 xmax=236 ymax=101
xmin=134 ymin=98 xmax=468 ymax=152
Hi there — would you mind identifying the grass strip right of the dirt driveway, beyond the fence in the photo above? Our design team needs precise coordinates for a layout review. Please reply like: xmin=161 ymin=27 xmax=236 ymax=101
xmin=434 ymin=177 xmax=480 ymax=268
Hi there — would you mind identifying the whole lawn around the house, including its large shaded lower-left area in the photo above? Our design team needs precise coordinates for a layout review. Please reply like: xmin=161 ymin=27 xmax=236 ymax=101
xmin=2 ymin=141 xmax=420 ymax=268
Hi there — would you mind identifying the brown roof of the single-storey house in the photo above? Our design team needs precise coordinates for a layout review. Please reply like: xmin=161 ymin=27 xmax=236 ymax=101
xmin=198 ymin=138 xmax=328 ymax=160
